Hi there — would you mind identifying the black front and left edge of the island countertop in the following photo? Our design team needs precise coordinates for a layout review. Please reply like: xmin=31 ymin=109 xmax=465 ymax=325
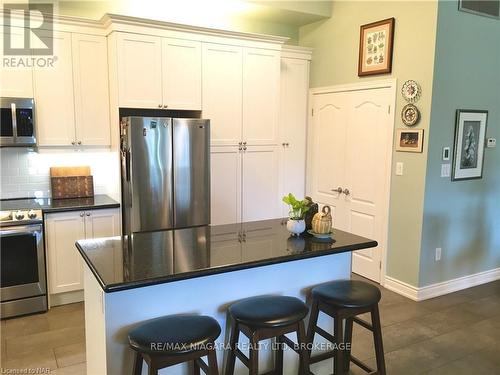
xmin=75 ymin=240 xmax=378 ymax=293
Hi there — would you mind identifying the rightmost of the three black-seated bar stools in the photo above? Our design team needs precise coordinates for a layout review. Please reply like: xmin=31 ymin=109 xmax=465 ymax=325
xmin=307 ymin=280 xmax=386 ymax=375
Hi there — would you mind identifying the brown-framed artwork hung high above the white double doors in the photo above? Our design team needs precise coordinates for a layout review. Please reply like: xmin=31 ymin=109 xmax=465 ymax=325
xmin=358 ymin=18 xmax=395 ymax=77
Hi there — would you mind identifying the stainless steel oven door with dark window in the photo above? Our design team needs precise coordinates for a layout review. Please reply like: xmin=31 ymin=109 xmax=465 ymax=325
xmin=0 ymin=224 xmax=47 ymax=302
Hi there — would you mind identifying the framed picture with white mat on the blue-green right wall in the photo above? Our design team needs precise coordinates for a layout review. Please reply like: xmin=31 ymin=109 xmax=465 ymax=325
xmin=451 ymin=109 xmax=488 ymax=181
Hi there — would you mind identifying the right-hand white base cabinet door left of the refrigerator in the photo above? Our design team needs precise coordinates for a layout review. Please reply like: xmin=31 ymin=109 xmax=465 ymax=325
xmin=85 ymin=208 xmax=121 ymax=239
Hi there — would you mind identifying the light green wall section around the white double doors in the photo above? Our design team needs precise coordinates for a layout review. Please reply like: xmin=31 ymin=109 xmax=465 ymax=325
xmin=299 ymin=1 xmax=437 ymax=286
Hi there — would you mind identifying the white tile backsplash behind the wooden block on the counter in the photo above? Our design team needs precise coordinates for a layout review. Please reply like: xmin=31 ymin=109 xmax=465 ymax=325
xmin=0 ymin=148 xmax=120 ymax=199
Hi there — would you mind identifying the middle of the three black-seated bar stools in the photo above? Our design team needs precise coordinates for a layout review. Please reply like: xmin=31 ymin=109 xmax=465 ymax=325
xmin=225 ymin=296 xmax=309 ymax=375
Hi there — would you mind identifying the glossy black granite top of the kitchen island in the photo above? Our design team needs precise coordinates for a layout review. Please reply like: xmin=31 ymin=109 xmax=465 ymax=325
xmin=76 ymin=219 xmax=377 ymax=292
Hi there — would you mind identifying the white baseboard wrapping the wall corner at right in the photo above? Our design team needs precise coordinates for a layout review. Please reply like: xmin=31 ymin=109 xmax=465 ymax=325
xmin=384 ymin=268 xmax=500 ymax=301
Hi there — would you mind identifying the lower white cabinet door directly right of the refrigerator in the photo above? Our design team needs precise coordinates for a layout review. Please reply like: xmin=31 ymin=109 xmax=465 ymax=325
xmin=210 ymin=146 xmax=241 ymax=225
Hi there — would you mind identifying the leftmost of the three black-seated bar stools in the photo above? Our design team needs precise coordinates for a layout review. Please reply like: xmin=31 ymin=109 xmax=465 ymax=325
xmin=128 ymin=315 xmax=221 ymax=375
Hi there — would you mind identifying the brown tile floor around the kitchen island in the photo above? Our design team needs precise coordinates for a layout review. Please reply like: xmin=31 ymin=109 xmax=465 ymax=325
xmin=0 ymin=276 xmax=500 ymax=375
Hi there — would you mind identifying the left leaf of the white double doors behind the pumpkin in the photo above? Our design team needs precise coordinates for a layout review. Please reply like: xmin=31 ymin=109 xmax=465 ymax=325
xmin=310 ymin=93 xmax=349 ymax=230
